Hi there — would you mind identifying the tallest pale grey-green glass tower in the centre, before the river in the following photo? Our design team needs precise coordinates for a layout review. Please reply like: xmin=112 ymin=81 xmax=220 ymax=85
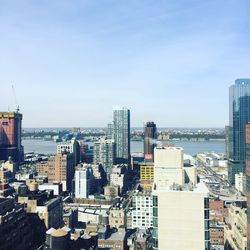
xmin=113 ymin=107 xmax=130 ymax=164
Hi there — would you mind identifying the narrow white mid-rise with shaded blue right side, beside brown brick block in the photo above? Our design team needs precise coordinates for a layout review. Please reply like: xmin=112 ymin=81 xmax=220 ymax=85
xmin=75 ymin=164 xmax=94 ymax=199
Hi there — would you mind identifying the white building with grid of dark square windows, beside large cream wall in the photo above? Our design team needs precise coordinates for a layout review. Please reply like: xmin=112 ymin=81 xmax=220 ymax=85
xmin=132 ymin=192 xmax=153 ymax=229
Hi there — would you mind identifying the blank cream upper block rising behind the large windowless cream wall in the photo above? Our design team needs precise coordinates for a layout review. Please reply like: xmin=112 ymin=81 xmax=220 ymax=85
xmin=154 ymin=147 xmax=185 ymax=187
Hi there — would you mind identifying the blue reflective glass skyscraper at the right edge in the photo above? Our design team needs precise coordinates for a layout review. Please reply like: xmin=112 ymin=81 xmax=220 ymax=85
xmin=228 ymin=79 xmax=250 ymax=184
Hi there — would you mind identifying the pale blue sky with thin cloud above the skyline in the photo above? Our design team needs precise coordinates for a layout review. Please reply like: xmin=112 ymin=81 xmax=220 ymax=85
xmin=0 ymin=0 xmax=250 ymax=127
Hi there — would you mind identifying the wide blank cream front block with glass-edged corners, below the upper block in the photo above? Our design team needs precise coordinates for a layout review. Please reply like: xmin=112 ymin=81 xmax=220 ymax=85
xmin=153 ymin=183 xmax=209 ymax=250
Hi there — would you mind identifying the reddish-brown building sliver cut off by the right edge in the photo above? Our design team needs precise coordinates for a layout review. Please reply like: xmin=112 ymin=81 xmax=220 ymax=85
xmin=246 ymin=123 xmax=250 ymax=250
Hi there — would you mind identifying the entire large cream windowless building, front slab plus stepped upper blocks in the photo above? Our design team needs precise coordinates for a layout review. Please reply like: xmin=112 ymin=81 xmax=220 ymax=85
xmin=152 ymin=147 xmax=210 ymax=250
